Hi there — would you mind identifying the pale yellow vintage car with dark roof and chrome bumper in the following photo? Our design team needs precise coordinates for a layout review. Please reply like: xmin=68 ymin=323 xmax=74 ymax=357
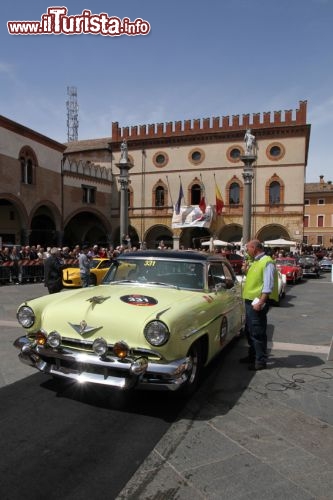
xmin=14 ymin=250 xmax=244 ymax=393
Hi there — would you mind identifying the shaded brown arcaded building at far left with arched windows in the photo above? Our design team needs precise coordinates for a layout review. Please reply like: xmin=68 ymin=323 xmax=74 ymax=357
xmin=0 ymin=116 xmax=112 ymax=246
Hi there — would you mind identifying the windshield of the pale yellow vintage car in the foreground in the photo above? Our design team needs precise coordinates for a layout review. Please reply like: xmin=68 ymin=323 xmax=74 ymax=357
xmin=103 ymin=258 xmax=204 ymax=290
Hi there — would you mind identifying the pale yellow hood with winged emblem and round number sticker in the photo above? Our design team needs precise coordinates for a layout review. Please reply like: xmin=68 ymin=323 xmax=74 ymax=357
xmin=24 ymin=284 xmax=207 ymax=345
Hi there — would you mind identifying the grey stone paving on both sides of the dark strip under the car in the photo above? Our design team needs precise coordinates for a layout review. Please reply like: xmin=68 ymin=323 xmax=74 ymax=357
xmin=0 ymin=275 xmax=333 ymax=500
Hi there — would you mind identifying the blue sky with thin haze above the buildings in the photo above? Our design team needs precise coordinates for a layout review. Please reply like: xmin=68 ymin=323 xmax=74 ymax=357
xmin=0 ymin=0 xmax=333 ymax=182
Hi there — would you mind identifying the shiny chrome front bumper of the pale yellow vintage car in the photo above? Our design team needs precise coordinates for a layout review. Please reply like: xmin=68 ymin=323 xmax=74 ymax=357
xmin=14 ymin=336 xmax=192 ymax=391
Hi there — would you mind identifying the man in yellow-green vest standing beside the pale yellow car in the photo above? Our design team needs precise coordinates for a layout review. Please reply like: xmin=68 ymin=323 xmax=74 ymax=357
xmin=240 ymin=240 xmax=279 ymax=371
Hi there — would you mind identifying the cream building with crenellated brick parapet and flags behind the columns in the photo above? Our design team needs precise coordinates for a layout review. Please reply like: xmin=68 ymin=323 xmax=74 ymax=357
xmin=64 ymin=101 xmax=310 ymax=248
